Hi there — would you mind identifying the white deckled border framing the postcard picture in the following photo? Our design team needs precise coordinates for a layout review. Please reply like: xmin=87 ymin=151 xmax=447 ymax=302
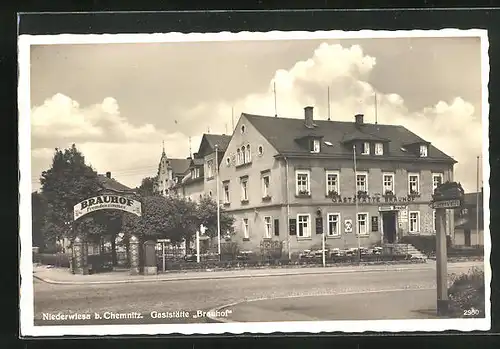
xmin=18 ymin=29 xmax=491 ymax=336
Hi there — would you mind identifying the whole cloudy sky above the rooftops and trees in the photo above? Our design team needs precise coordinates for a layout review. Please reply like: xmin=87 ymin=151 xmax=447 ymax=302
xmin=30 ymin=37 xmax=483 ymax=192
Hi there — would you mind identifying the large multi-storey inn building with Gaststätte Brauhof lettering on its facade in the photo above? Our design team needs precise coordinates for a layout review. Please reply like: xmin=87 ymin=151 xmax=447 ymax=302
xmin=216 ymin=107 xmax=456 ymax=253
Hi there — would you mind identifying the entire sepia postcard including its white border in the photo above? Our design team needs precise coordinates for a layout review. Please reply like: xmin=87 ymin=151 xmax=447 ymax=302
xmin=18 ymin=29 xmax=491 ymax=336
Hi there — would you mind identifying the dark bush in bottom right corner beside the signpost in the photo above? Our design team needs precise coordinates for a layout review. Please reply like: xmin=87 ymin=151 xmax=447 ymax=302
xmin=448 ymin=268 xmax=485 ymax=318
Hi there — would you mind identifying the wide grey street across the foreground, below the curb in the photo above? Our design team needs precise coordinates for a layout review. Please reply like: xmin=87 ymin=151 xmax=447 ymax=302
xmin=34 ymin=264 xmax=482 ymax=325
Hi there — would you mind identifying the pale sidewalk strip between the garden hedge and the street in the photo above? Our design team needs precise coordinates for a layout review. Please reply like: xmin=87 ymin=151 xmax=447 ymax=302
xmin=33 ymin=261 xmax=483 ymax=285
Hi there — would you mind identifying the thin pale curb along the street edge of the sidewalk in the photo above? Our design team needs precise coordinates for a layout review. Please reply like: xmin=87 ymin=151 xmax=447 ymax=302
xmin=33 ymin=267 xmax=432 ymax=285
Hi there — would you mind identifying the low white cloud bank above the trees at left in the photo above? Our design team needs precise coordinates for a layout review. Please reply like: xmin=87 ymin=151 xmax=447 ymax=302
xmin=31 ymin=94 xmax=201 ymax=189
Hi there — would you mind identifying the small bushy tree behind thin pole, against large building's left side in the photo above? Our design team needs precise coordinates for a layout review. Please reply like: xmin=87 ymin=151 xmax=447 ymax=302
xmin=196 ymin=196 xmax=234 ymax=237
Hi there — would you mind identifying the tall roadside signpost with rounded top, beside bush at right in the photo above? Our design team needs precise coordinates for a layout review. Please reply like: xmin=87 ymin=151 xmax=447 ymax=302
xmin=431 ymin=182 xmax=464 ymax=316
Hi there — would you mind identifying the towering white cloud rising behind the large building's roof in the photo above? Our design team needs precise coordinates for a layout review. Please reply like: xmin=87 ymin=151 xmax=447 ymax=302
xmin=182 ymin=43 xmax=482 ymax=191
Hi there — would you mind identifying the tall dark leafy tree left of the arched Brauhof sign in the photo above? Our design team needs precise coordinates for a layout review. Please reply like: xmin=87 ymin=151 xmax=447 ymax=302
xmin=40 ymin=144 xmax=100 ymax=241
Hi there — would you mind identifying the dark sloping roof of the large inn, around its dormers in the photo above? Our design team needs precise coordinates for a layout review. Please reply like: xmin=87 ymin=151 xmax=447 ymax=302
xmin=242 ymin=113 xmax=456 ymax=163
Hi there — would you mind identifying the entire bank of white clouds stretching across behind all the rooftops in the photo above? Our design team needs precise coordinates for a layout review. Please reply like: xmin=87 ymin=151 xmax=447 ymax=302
xmin=32 ymin=43 xmax=482 ymax=191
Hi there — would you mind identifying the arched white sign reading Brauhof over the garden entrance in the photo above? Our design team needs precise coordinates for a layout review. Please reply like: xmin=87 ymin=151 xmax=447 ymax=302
xmin=73 ymin=195 xmax=142 ymax=220
